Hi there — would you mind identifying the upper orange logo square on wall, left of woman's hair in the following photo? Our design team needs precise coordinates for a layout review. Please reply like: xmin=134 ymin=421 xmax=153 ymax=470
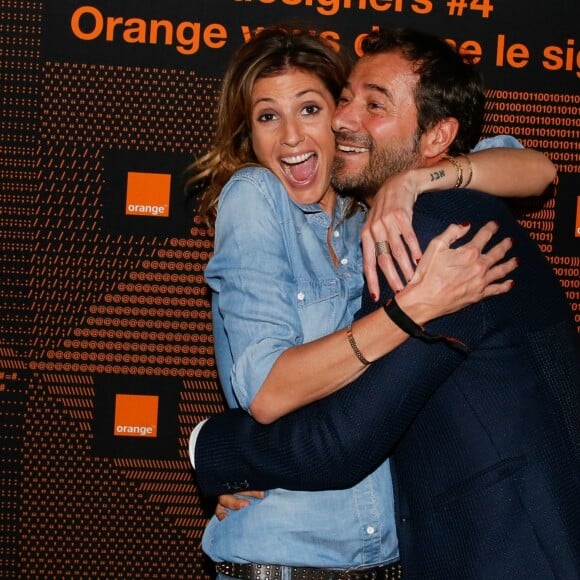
xmin=125 ymin=171 xmax=171 ymax=218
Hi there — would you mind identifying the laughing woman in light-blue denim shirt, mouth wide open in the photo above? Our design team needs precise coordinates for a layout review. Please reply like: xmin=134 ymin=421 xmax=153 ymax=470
xmin=188 ymin=29 xmax=556 ymax=573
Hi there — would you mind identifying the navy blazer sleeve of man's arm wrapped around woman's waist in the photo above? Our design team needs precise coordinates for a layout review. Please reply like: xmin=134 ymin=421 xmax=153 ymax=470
xmin=195 ymin=204 xmax=498 ymax=495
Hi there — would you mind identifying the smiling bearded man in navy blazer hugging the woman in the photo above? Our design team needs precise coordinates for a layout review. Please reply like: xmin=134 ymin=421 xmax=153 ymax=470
xmin=195 ymin=31 xmax=580 ymax=580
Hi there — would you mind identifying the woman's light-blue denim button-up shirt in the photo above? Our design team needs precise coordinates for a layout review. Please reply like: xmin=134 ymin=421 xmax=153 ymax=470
xmin=203 ymin=167 xmax=398 ymax=568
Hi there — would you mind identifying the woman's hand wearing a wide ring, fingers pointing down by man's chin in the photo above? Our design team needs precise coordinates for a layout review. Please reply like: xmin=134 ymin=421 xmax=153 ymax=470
xmin=361 ymin=170 xmax=424 ymax=300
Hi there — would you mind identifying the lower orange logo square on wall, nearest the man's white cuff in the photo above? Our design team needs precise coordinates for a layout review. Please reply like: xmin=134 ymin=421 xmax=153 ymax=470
xmin=113 ymin=394 xmax=159 ymax=437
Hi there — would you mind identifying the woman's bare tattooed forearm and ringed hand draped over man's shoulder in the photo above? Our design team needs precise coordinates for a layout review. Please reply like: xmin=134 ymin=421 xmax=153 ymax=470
xmin=361 ymin=146 xmax=556 ymax=300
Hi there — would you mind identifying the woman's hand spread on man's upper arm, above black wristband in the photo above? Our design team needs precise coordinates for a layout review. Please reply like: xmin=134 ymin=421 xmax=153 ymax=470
xmin=397 ymin=221 xmax=517 ymax=324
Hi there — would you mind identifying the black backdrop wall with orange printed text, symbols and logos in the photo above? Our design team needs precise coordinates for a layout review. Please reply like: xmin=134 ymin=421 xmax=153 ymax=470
xmin=0 ymin=0 xmax=580 ymax=578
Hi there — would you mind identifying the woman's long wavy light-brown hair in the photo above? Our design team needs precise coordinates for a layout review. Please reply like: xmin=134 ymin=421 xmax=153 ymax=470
xmin=188 ymin=26 xmax=352 ymax=224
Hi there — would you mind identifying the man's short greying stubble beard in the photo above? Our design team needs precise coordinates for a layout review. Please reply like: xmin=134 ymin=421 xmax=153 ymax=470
xmin=332 ymin=131 xmax=421 ymax=201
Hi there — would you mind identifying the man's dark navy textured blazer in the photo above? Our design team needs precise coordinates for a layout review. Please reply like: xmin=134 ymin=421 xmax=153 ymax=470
xmin=195 ymin=190 xmax=580 ymax=580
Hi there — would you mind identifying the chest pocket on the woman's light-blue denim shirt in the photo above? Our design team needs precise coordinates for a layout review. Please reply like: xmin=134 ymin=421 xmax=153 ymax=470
xmin=296 ymin=278 xmax=346 ymax=342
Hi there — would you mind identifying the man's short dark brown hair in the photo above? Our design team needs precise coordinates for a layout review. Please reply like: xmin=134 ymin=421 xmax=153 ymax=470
xmin=362 ymin=28 xmax=485 ymax=155
